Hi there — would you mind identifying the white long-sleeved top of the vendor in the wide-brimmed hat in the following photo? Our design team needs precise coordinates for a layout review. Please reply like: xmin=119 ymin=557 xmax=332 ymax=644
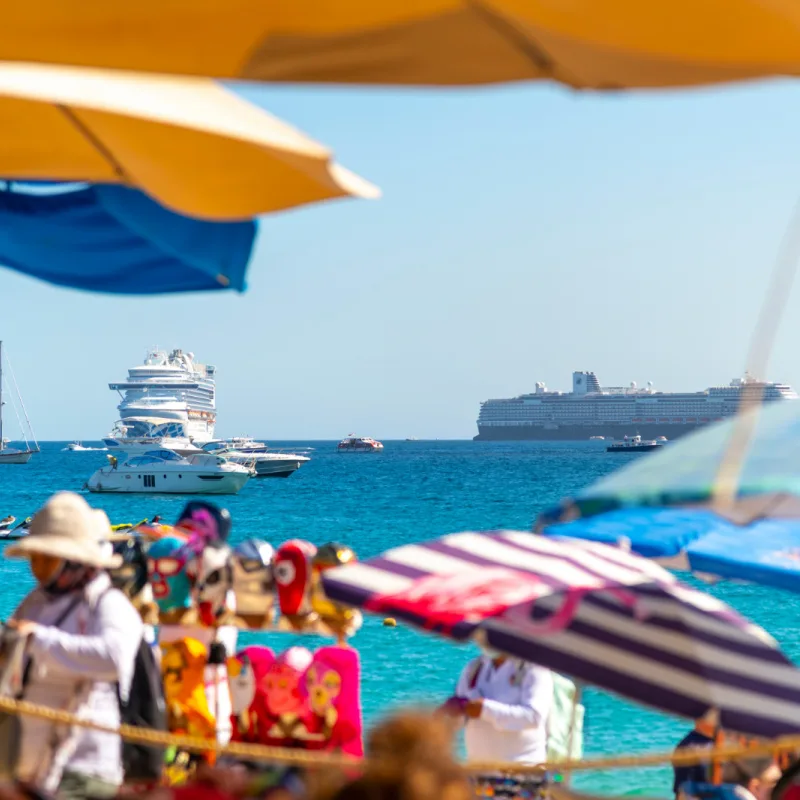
xmin=14 ymin=574 xmax=142 ymax=791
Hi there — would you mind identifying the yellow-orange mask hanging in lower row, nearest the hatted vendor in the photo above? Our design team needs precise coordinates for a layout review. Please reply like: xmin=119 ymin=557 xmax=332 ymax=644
xmin=161 ymin=638 xmax=217 ymax=739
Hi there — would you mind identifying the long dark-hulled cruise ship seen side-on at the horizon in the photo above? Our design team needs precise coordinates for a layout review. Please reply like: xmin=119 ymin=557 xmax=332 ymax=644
xmin=475 ymin=372 xmax=797 ymax=441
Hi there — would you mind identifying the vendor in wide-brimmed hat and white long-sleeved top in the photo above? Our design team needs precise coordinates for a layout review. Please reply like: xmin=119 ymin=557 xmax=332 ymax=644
xmin=4 ymin=492 xmax=142 ymax=797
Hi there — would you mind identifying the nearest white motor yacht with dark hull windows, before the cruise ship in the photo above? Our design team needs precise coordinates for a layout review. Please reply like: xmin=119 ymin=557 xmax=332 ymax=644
xmin=86 ymin=448 xmax=253 ymax=494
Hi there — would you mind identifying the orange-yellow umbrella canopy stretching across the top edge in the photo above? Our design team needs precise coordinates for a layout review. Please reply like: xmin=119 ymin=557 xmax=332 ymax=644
xmin=0 ymin=0 xmax=800 ymax=89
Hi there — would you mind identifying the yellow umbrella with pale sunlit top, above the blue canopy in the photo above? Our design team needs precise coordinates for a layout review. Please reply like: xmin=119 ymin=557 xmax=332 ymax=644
xmin=0 ymin=63 xmax=378 ymax=220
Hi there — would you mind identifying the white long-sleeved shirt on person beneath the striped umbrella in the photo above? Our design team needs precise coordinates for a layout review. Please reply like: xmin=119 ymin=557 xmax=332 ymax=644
xmin=456 ymin=656 xmax=553 ymax=764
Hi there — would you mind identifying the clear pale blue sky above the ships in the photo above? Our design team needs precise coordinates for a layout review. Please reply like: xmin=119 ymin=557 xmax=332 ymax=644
xmin=0 ymin=78 xmax=800 ymax=439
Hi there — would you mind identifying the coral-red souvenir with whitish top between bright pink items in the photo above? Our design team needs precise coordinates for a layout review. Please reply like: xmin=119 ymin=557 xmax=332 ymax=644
xmin=259 ymin=647 xmax=313 ymax=747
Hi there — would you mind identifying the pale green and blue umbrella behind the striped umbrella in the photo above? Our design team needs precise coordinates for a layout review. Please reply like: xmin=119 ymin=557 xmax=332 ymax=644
xmin=536 ymin=401 xmax=800 ymax=591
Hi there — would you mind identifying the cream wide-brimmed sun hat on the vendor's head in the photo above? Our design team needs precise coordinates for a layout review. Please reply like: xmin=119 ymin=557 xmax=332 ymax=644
xmin=3 ymin=492 xmax=122 ymax=569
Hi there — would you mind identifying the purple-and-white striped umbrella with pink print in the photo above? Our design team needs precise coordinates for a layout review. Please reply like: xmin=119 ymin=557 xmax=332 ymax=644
xmin=322 ymin=531 xmax=800 ymax=737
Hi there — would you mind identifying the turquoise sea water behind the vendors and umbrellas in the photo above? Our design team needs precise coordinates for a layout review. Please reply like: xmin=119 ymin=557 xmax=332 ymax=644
xmin=0 ymin=441 xmax=800 ymax=796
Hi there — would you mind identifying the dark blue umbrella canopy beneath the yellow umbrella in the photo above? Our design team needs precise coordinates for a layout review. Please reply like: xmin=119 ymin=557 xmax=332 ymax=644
xmin=0 ymin=184 xmax=257 ymax=294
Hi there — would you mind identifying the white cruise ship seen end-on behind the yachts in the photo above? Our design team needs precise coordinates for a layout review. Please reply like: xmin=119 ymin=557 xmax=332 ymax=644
xmin=108 ymin=349 xmax=217 ymax=446
